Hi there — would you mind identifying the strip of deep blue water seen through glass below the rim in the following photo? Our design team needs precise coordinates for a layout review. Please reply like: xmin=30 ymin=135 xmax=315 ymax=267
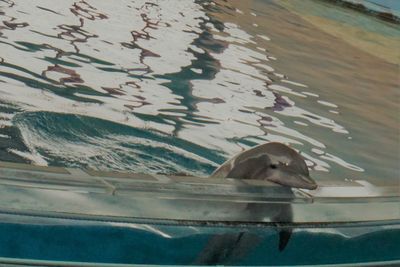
xmin=0 ymin=220 xmax=400 ymax=266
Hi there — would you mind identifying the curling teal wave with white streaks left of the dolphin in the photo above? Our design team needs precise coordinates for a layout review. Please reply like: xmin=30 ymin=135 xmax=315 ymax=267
xmin=13 ymin=111 xmax=224 ymax=176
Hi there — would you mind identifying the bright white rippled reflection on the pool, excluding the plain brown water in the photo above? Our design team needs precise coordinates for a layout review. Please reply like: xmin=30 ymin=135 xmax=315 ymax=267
xmin=0 ymin=0 xmax=394 ymax=183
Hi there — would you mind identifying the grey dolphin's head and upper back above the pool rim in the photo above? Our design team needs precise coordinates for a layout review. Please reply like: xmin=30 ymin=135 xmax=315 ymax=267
xmin=211 ymin=142 xmax=317 ymax=189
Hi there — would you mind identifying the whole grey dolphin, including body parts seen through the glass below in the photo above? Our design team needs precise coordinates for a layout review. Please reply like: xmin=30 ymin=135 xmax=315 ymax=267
xmin=195 ymin=142 xmax=318 ymax=264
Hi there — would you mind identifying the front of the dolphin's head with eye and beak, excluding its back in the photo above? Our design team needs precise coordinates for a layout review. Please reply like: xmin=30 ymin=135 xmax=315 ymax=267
xmin=248 ymin=143 xmax=317 ymax=189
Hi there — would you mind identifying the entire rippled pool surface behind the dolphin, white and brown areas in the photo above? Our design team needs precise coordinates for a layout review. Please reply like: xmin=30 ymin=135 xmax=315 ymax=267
xmin=0 ymin=0 xmax=399 ymax=184
